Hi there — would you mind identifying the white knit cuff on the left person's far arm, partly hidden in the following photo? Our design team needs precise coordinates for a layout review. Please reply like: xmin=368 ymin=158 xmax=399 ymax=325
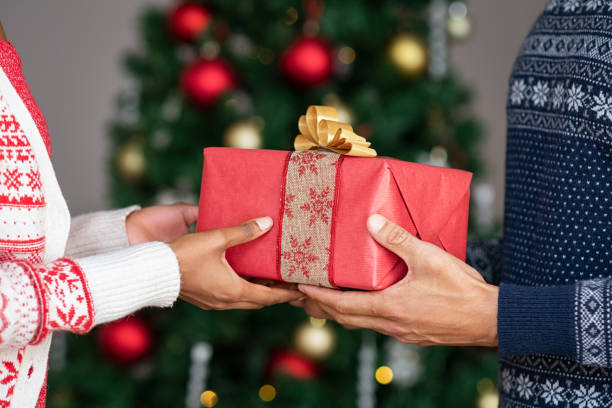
xmin=65 ymin=205 xmax=140 ymax=258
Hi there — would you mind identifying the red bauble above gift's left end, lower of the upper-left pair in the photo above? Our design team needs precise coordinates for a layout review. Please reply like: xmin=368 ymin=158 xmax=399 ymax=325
xmin=181 ymin=59 xmax=236 ymax=106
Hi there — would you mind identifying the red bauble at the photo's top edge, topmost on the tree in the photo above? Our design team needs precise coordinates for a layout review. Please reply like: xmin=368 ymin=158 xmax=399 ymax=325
xmin=168 ymin=3 xmax=212 ymax=41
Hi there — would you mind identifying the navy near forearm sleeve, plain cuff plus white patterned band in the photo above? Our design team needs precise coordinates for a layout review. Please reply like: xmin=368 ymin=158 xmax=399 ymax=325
xmin=498 ymin=277 xmax=612 ymax=367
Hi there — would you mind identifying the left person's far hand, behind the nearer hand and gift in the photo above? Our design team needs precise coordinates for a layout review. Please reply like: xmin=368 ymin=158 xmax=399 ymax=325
xmin=125 ymin=203 xmax=198 ymax=245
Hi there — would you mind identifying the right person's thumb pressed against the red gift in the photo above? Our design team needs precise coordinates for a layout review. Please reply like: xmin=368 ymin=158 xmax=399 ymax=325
xmin=368 ymin=214 xmax=421 ymax=261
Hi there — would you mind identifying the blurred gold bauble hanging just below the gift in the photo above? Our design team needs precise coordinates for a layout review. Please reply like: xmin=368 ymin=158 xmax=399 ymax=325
xmin=294 ymin=322 xmax=336 ymax=361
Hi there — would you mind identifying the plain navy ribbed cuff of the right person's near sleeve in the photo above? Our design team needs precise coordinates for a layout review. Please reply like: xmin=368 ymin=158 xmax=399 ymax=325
xmin=497 ymin=284 xmax=576 ymax=358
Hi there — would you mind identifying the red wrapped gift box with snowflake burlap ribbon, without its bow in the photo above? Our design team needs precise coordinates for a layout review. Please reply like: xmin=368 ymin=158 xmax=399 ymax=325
xmin=197 ymin=148 xmax=472 ymax=290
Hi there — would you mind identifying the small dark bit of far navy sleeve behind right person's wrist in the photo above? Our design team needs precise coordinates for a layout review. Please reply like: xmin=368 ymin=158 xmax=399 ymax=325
xmin=465 ymin=238 xmax=503 ymax=285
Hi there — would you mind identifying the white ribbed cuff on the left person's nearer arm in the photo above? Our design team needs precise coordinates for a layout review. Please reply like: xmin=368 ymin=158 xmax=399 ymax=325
xmin=76 ymin=242 xmax=181 ymax=325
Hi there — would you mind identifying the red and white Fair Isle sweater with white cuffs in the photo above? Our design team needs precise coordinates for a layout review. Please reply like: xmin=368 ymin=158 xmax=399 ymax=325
xmin=0 ymin=40 xmax=180 ymax=408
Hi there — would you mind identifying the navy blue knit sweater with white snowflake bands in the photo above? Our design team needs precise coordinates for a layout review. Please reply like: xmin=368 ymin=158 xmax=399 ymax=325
xmin=471 ymin=0 xmax=612 ymax=408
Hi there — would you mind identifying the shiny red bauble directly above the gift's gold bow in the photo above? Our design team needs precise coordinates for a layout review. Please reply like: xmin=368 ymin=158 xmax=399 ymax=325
xmin=280 ymin=37 xmax=333 ymax=86
